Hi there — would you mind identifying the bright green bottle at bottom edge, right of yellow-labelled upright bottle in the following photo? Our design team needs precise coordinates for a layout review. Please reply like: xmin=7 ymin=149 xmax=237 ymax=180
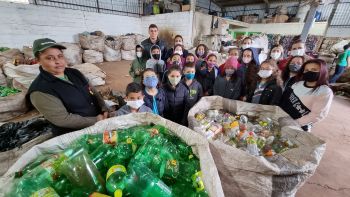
xmin=125 ymin=163 xmax=172 ymax=197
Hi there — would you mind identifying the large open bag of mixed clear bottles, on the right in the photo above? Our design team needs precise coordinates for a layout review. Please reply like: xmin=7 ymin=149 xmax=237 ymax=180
xmin=188 ymin=96 xmax=326 ymax=196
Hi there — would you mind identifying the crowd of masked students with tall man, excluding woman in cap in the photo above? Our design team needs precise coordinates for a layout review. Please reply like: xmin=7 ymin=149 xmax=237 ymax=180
xmin=127 ymin=24 xmax=333 ymax=131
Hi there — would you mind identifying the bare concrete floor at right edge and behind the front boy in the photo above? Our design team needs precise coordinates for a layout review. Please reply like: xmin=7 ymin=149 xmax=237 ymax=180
xmin=99 ymin=61 xmax=350 ymax=197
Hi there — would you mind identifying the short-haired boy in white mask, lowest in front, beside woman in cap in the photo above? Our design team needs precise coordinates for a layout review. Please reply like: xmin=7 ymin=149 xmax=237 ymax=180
xmin=116 ymin=82 xmax=152 ymax=116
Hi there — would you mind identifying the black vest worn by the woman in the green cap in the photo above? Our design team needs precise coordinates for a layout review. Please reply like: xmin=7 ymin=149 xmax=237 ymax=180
xmin=26 ymin=66 xmax=101 ymax=117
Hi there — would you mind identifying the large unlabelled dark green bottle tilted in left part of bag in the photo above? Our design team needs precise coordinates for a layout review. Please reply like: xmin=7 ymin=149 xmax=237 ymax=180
xmin=59 ymin=148 xmax=105 ymax=193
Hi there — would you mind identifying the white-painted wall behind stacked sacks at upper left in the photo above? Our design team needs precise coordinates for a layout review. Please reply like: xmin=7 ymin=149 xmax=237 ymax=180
xmin=0 ymin=1 xmax=143 ymax=48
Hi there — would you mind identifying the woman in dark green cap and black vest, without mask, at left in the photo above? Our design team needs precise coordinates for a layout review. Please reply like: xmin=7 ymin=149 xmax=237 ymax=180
xmin=27 ymin=38 xmax=108 ymax=134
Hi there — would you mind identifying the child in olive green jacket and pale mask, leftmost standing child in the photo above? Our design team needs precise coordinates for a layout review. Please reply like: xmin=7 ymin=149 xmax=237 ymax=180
xmin=129 ymin=45 xmax=146 ymax=83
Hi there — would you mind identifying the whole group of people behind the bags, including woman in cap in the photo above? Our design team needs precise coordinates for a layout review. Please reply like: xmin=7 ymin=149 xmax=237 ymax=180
xmin=27 ymin=24 xmax=340 ymax=135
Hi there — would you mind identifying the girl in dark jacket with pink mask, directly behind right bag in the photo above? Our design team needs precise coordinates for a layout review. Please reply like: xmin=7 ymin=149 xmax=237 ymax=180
xmin=214 ymin=56 xmax=241 ymax=100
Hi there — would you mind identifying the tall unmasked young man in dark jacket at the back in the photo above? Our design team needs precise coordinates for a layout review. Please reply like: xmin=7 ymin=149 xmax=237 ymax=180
xmin=141 ymin=24 xmax=167 ymax=62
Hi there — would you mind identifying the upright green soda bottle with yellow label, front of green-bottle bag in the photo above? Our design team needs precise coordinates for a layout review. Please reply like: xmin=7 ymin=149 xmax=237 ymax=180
xmin=106 ymin=165 xmax=126 ymax=197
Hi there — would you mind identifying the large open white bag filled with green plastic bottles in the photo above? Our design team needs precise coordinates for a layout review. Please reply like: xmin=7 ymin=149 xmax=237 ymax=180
xmin=0 ymin=113 xmax=224 ymax=197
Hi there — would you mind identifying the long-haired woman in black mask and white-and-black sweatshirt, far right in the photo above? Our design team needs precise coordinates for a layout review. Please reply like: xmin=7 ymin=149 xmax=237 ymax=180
xmin=280 ymin=59 xmax=333 ymax=132
